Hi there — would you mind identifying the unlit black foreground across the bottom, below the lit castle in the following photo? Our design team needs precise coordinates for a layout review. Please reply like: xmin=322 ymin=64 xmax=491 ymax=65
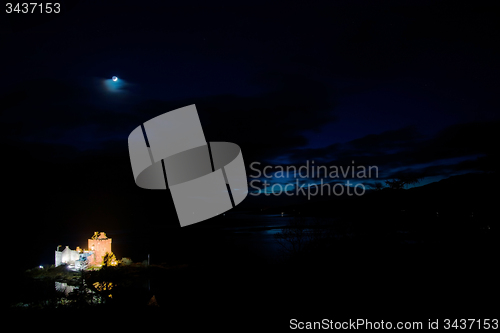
xmin=7 ymin=220 xmax=499 ymax=330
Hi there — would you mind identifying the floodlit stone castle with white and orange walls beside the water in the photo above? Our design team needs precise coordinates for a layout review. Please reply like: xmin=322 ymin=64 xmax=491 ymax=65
xmin=55 ymin=231 xmax=112 ymax=269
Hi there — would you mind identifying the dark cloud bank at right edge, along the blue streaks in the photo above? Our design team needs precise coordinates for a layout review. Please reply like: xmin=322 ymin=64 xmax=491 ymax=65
xmin=272 ymin=121 xmax=500 ymax=182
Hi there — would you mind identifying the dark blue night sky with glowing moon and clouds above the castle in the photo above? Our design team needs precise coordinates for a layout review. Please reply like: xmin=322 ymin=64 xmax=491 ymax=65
xmin=0 ymin=0 xmax=500 ymax=264
